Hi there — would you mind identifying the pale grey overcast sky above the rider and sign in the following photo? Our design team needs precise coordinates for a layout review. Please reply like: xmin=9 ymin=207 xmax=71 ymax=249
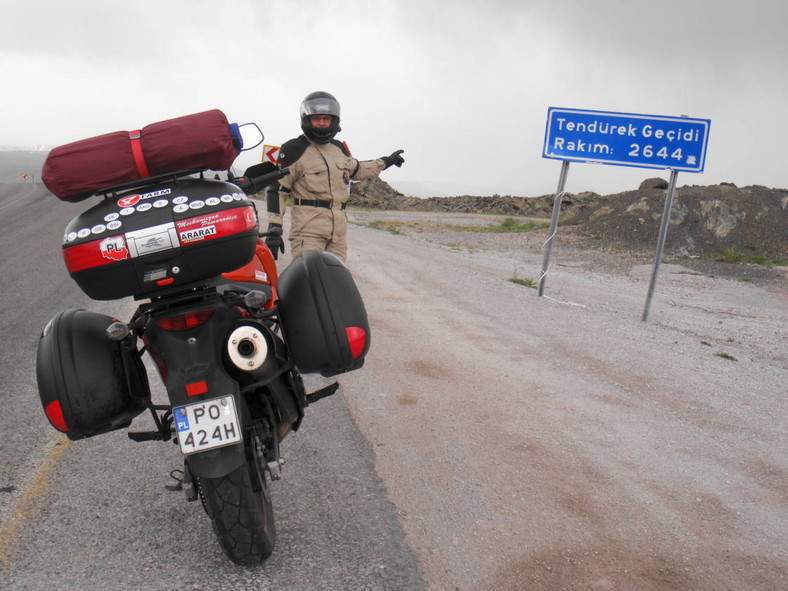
xmin=0 ymin=0 xmax=788 ymax=196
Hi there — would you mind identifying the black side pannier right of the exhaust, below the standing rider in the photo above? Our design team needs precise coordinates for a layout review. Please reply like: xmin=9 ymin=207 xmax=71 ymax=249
xmin=277 ymin=250 xmax=370 ymax=376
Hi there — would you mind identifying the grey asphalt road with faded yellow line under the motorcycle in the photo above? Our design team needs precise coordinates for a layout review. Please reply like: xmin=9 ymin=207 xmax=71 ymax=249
xmin=0 ymin=184 xmax=424 ymax=591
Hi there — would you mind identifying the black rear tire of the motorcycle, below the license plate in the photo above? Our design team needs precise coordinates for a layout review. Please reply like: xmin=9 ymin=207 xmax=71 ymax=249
xmin=198 ymin=464 xmax=276 ymax=566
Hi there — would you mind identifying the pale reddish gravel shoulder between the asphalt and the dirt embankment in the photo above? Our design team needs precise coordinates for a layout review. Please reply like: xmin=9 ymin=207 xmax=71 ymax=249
xmin=342 ymin=210 xmax=788 ymax=591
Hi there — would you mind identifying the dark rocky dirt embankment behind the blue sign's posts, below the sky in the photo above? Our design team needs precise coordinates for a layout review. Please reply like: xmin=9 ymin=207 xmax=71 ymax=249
xmin=351 ymin=179 xmax=788 ymax=261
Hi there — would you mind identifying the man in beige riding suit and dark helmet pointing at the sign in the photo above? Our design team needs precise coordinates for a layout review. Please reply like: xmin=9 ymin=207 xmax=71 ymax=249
xmin=265 ymin=92 xmax=405 ymax=261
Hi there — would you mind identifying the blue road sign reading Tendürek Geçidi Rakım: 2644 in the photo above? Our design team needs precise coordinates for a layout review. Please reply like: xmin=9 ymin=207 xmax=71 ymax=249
xmin=542 ymin=107 xmax=711 ymax=172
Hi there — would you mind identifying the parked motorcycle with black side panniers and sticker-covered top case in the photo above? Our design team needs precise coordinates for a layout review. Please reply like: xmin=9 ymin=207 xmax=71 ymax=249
xmin=36 ymin=148 xmax=370 ymax=565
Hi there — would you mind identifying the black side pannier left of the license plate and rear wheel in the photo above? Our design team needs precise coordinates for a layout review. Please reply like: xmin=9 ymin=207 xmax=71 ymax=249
xmin=36 ymin=308 xmax=150 ymax=440
